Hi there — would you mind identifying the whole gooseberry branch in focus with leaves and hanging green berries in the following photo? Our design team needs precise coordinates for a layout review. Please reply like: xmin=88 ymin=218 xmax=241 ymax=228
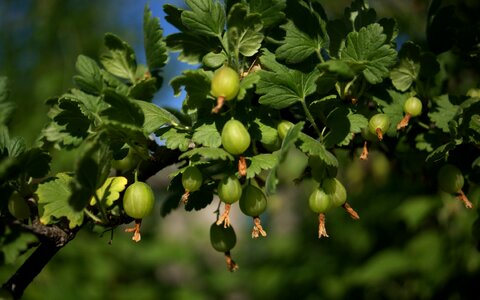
xmin=0 ymin=0 xmax=480 ymax=298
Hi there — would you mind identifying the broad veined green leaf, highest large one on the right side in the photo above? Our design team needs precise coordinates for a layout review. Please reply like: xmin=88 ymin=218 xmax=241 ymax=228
xmin=340 ymin=23 xmax=397 ymax=84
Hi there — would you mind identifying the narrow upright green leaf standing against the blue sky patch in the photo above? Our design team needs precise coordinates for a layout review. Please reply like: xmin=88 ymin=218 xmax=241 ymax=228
xmin=143 ymin=5 xmax=168 ymax=74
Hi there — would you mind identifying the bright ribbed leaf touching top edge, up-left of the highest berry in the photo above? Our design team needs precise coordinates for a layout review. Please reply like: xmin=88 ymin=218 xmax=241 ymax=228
xmin=181 ymin=0 xmax=225 ymax=36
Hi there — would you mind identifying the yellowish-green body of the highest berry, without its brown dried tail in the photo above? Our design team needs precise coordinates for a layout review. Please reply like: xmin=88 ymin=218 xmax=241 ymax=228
xmin=210 ymin=66 xmax=240 ymax=101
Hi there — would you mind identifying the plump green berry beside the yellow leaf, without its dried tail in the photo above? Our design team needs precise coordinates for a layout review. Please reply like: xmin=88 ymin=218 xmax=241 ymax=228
xmin=123 ymin=181 xmax=155 ymax=219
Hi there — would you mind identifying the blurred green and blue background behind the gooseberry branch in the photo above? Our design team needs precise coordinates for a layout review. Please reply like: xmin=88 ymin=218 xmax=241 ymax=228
xmin=0 ymin=0 xmax=480 ymax=300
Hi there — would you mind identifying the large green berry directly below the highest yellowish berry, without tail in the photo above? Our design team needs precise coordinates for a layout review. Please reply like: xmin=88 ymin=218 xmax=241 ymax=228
xmin=221 ymin=119 xmax=251 ymax=155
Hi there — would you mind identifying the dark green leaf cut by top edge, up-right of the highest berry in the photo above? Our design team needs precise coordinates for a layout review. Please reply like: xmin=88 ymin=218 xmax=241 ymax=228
xmin=248 ymin=0 xmax=287 ymax=27
